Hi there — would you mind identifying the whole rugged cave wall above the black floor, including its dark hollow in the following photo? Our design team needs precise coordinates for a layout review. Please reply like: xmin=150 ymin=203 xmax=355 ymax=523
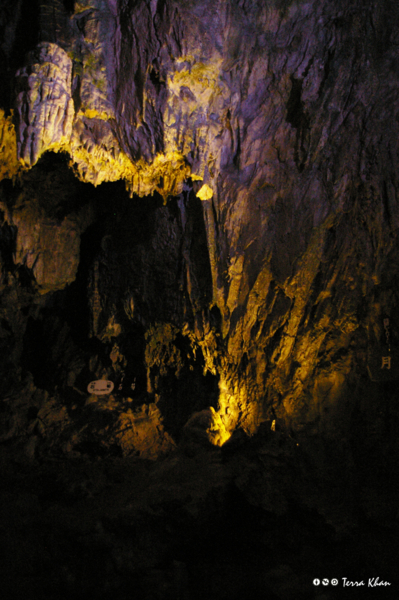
xmin=0 ymin=0 xmax=399 ymax=457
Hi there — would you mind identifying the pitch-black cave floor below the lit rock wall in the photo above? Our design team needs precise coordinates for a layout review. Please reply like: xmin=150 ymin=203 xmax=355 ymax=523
xmin=0 ymin=440 xmax=399 ymax=600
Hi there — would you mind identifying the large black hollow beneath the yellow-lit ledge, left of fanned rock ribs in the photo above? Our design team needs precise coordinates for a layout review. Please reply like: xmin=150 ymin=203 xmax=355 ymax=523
xmin=7 ymin=152 xmax=219 ymax=454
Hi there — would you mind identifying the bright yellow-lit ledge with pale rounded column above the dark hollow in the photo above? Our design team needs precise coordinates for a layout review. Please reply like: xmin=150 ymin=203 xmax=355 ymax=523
xmin=12 ymin=42 xmax=191 ymax=202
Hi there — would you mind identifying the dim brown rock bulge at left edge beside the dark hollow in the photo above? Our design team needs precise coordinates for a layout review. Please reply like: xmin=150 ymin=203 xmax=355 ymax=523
xmin=0 ymin=151 xmax=90 ymax=294
